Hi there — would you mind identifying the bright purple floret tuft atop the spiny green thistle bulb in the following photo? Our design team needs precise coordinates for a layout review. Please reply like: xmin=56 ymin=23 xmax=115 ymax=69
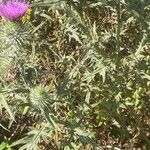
xmin=0 ymin=0 xmax=30 ymax=21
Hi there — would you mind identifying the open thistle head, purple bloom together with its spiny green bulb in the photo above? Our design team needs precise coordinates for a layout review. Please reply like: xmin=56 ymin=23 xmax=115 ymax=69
xmin=0 ymin=0 xmax=30 ymax=48
